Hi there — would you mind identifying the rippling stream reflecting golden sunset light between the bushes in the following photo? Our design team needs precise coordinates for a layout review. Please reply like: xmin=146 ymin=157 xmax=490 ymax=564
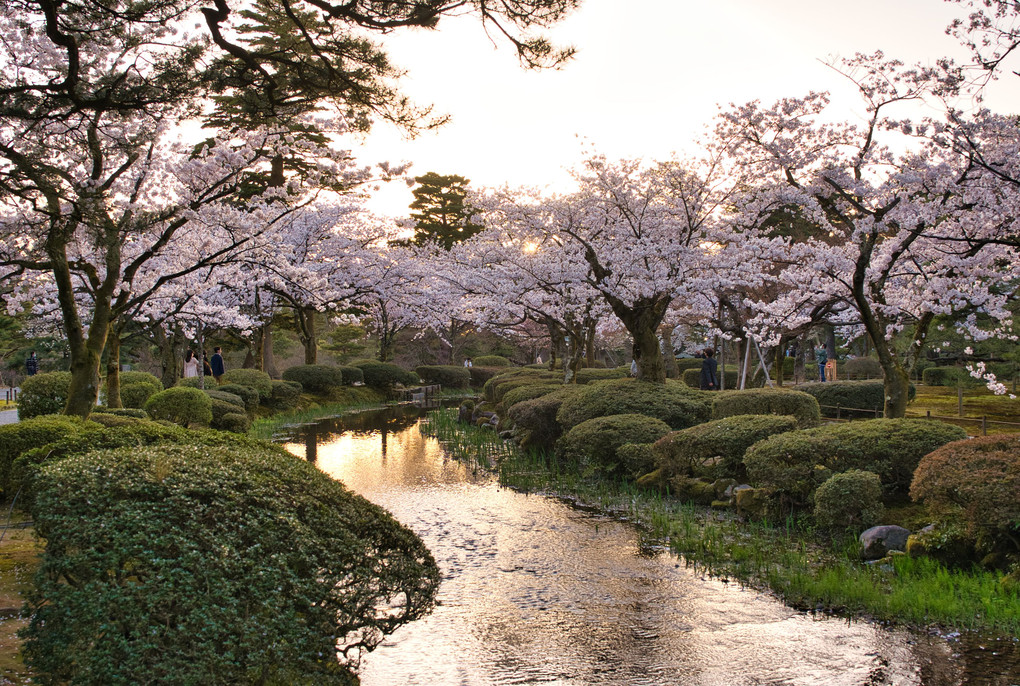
xmin=287 ymin=410 xmax=1020 ymax=686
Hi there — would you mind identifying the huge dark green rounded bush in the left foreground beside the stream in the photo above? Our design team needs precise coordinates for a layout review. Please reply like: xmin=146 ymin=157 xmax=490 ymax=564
xmin=23 ymin=442 xmax=440 ymax=684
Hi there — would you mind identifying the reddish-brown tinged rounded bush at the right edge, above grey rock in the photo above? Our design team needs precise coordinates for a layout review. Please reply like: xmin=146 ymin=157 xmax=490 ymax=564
xmin=910 ymin=434 xmax=1020 ymax=558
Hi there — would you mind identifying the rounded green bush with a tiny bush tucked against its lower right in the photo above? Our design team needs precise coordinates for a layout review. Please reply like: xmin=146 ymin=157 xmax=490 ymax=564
xmin=557 ymin=408 xmax=669 ymax=478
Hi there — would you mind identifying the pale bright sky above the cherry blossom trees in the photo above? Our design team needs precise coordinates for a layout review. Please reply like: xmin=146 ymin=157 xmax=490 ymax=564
xmin=354 ymin=0 xmax=1020 ymax=214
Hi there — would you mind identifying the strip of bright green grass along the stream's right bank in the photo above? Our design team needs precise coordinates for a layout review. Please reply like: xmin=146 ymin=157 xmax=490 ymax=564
xmin=426 ymin=412 xmax=1020 ymax=636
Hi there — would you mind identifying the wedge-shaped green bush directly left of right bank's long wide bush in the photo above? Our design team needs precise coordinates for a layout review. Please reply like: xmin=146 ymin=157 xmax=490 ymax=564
xmin=654 ymin=415 xmax=797 ymax=479
